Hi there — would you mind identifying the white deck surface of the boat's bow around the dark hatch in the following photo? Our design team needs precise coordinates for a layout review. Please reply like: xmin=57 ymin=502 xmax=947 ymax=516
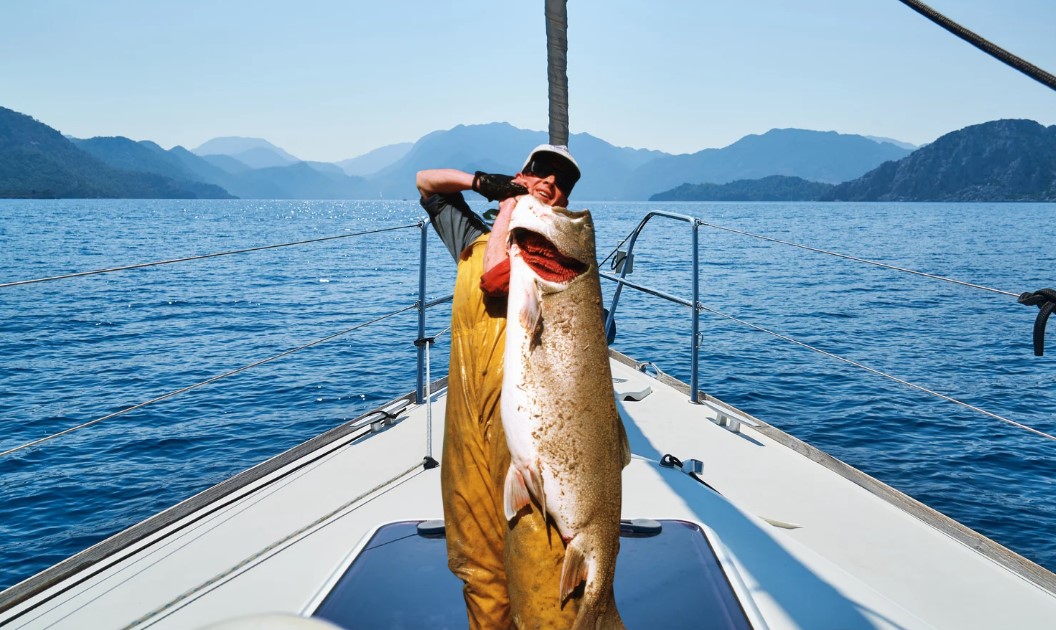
xmin=6 ymin=361 xmax=1056 ymax=629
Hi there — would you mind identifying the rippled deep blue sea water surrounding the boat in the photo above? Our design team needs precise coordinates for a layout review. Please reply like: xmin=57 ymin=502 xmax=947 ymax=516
xmin=0 ymin=201 xmax=1056 ymax=588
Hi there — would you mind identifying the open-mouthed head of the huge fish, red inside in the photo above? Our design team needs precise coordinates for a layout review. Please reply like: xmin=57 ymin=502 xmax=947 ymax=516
xmin=507 ymin=195 xmax=597 ymax=290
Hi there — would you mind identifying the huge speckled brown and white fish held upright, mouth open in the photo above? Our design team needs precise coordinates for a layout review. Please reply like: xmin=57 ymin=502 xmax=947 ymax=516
xmin=502 ymin=196 xmax=630 ymax=628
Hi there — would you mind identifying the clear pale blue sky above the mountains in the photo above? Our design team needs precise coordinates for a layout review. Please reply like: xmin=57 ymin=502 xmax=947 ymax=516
xmin=0 ymin=0 xmax=1056 ymax=161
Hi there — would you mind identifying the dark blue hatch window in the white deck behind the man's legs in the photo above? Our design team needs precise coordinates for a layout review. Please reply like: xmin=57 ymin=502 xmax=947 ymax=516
xmin=314 ymin=520 xmax=751 ymax=629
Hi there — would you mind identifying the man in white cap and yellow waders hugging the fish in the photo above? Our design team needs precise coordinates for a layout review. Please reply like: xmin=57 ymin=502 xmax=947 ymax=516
xmin=416 ymin=145 xmax=580 ymax=628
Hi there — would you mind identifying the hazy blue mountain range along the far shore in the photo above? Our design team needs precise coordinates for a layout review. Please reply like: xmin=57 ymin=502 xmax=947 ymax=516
xmin=0 ymin=103 xmax=1056 ymax=201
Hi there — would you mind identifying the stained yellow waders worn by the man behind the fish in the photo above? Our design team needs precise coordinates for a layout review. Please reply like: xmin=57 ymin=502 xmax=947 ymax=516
xmin=440 ymin=234 xmax=579 ymax=629
